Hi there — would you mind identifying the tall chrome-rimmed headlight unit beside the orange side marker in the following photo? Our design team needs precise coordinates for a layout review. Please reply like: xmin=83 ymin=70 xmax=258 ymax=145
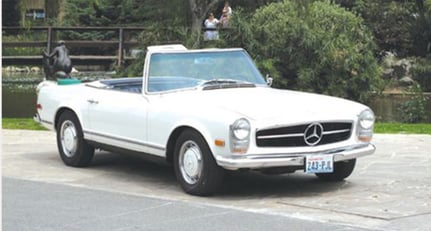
xmin=230 ymin=118 xmax=251 ymax=153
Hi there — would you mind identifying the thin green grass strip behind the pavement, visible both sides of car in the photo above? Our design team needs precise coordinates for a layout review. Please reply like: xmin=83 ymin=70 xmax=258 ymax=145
xmin=2 ymin=118 xmax=431 ymax=135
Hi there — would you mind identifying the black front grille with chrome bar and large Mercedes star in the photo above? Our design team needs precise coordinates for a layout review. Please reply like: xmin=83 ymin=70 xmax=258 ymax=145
xmin=256 ymin=122 xmax=352 ymax=147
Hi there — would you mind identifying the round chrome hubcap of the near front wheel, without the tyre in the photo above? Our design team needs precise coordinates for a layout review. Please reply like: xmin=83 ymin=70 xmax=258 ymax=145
xmin=179 ymin=140 xmax=202 ymax=184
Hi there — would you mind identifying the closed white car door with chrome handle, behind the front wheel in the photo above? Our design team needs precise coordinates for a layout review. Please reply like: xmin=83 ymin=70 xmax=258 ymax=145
xmin=87 ymin=89 xmax=151 ymax=152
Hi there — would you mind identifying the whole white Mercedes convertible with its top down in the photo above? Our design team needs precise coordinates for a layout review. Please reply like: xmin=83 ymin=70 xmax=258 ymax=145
xmin=35 ymin=45 xmax=375 ymax=195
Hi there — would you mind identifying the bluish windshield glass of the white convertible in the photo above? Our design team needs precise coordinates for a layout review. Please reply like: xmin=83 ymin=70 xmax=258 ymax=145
xmin=147 ymin=50 xmax=266 ymax=92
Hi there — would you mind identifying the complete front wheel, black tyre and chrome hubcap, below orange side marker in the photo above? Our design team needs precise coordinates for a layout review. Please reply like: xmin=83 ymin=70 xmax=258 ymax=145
xmin=174 ymin=130 xmax=224 ymax=196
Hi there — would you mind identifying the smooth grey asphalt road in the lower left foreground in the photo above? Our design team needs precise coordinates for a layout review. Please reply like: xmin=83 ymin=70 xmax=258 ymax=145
xmin=3 ymin=178 xmax=372 ymax=231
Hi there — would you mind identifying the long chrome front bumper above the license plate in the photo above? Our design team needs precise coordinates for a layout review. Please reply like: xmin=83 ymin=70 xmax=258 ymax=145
xmin=216 ymin=144 xmax=376 ymax=170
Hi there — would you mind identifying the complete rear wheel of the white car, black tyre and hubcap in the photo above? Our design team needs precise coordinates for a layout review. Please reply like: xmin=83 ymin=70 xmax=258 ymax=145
xmin=57 ymin=111 xmax=94 ymax=167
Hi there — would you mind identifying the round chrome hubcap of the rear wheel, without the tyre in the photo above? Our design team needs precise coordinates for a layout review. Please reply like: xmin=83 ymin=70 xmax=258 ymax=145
xmin=60 ymin=120 xmax=78 ymax=158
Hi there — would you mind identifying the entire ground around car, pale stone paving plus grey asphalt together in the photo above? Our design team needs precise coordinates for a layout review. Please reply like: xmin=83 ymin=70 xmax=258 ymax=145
xmin=2 ymin=130 xmax=431 ymax=230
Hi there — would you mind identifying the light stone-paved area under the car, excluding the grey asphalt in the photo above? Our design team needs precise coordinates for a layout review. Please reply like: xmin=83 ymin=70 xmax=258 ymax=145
xmin=1 ymin=130 xmax=431 ymax=230
